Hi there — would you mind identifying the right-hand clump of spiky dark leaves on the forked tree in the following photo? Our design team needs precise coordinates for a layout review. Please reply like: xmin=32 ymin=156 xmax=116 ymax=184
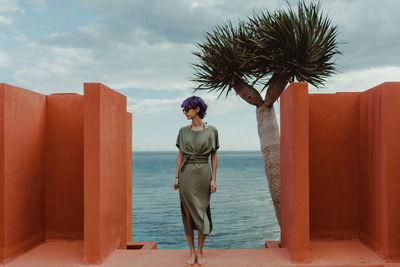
xmin=247 ymin=1 xmax=341 ymax=87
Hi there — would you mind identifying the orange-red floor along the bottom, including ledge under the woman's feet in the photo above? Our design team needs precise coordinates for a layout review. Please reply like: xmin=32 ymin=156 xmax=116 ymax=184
xmin=3 ymin=240 xmax=400 ymax=267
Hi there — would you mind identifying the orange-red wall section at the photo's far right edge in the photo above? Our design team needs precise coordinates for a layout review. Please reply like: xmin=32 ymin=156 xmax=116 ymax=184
xmin=359 ymin=83 xmax=400 ymax=259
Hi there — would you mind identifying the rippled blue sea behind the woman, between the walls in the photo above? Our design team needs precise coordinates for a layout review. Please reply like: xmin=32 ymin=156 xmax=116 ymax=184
xmin=132 ymin=151 xmax=280 ymax=249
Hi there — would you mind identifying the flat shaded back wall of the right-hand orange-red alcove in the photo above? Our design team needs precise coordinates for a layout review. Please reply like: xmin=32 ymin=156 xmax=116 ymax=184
xmin=309 ymin=93 xmax=360 ymax=239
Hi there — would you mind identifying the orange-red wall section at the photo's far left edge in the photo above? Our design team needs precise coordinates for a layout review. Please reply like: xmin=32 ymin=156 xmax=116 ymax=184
xmin=0 ymin=84 xmax=46 ymax=262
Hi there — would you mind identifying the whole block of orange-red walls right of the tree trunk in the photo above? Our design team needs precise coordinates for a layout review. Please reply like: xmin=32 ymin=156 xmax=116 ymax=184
xmin=281 ymin=82 xmax=400 ymax=262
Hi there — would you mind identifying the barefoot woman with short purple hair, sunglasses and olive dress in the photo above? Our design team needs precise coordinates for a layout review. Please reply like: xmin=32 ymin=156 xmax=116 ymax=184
xmin=173 ymin=96 xmax=219 ymax=265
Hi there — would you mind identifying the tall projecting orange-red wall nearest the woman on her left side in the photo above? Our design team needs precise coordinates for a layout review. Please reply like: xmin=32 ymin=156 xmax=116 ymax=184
xmin=84 ymin=83 xmax=128 ymax=263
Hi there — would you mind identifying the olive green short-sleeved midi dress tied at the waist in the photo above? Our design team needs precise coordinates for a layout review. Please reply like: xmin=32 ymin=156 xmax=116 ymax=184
xmin=176 ymin=125 xmax=219 ymax=235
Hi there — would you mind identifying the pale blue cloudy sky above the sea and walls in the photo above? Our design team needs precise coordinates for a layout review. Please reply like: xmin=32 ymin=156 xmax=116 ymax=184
xmin=0 ymin=0 xmax=400 ymax=151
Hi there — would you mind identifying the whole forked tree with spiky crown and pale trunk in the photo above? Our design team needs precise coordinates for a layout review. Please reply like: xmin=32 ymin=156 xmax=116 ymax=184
xmin=193 ymin=1 xmax=340 ymax=227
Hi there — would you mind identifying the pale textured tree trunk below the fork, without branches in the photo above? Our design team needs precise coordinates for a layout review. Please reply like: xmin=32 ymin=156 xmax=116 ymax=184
xmin=256 ymin=103 xmax=281 ymax=225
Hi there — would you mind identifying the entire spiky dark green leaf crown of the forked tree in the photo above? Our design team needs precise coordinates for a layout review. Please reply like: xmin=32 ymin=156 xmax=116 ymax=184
xmin=192 ymin=0 xmax=341 ymax=96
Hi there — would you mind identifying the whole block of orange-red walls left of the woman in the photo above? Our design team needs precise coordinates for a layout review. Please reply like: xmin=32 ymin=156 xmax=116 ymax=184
xmin=0 ymin=83 xmax=132 ymax=263
